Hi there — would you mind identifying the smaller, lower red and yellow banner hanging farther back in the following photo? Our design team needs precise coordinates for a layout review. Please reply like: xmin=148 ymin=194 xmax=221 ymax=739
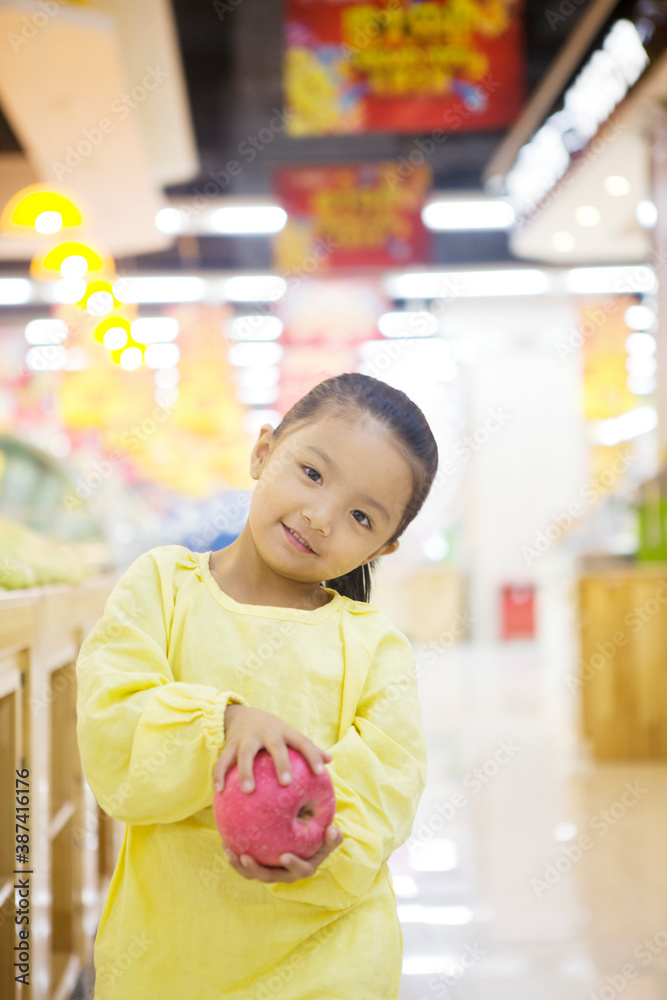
xmin=273 ymin=161 xmax=431 ymax=277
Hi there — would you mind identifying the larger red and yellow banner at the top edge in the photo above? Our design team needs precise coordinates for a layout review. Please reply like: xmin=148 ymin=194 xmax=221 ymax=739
xmin=284 ymin=0 xmax=523 ymax=138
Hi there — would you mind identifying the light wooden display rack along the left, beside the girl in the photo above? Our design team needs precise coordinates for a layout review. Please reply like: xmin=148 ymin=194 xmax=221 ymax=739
xmin=0 ymin=576 xmax=118 ymax=1000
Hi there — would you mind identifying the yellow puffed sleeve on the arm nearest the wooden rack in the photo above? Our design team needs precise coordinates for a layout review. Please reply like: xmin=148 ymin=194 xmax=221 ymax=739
xmin=76 ymin=549 xmax=247 ymax=824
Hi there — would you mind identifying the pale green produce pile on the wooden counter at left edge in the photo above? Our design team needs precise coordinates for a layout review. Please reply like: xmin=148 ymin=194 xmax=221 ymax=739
xmin=0 ymin=515 xmax=88 ymax=591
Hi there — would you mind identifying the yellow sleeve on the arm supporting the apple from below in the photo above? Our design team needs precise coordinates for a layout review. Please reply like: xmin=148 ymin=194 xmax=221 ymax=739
xmin=264 ymin=630 xmax=426 ymax=910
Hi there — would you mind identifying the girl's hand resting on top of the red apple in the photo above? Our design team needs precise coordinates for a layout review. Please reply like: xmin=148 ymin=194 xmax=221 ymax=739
xmin=213 ymin=704 xmax=332 ymax=792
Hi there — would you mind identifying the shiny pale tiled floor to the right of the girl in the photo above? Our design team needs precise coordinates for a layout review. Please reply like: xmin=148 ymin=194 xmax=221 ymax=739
xmin=390 ymin=642 xmax=667 ymax=1000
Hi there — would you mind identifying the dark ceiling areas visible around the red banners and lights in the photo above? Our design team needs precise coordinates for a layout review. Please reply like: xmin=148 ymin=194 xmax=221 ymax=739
xmin=0 ymin=0 xmax=592 ymax=271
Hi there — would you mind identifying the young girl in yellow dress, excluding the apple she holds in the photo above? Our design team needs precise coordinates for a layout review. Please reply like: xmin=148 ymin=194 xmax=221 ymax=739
xmin=77 ymin=374 xmax=438 ymax=1000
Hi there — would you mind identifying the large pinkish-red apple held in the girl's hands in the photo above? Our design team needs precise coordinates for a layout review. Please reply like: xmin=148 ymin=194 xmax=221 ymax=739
xmin=213 ymin=747 xmax=336 ymax=867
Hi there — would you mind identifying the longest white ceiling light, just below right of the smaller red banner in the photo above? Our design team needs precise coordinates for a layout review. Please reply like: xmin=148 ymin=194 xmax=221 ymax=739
xmin=385 ymin=268 xmax=549 ymax=299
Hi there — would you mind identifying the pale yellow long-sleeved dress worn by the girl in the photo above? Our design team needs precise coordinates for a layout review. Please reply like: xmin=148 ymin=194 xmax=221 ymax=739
xmin=77 ymin=545 xmax=426 ymax=1000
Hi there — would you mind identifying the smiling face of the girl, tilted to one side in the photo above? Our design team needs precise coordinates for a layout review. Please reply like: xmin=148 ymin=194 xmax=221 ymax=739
xmin=248 ymin=412 xmax=413 ymax=583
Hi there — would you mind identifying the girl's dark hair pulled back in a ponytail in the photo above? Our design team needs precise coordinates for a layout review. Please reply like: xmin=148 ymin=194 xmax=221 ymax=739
xmin=274 ymin=372 xmax=438 ymax=603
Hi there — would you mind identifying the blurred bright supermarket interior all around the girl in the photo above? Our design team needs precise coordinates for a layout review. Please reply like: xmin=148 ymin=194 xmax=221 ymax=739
xmin=0 ymin=0 xmax=667 ymax=1000
